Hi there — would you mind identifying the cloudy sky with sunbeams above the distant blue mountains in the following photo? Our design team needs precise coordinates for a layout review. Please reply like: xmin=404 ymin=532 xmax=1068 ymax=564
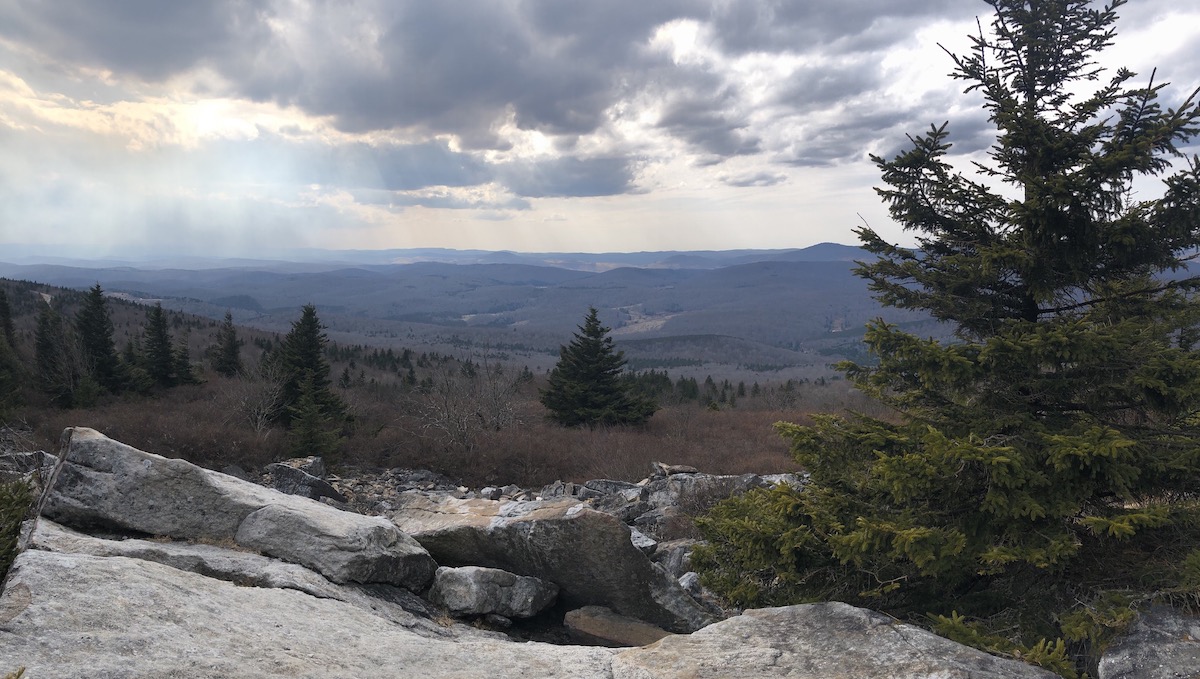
xmin=0 ymin=0 xmax=1200 ymax=257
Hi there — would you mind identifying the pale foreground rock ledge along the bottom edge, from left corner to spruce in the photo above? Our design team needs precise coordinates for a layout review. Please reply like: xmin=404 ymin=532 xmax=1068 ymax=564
xmin=0 ymin=542 xmax=1054 ymax=679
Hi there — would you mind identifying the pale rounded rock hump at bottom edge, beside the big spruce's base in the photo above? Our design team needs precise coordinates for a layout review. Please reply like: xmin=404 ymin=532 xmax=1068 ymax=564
xmin=612 ymin=603 xmax=1057 ymax=679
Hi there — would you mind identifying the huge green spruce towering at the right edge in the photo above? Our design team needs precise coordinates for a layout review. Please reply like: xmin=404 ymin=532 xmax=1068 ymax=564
xmin=697 ymin=0 xmax=1200 ymax=667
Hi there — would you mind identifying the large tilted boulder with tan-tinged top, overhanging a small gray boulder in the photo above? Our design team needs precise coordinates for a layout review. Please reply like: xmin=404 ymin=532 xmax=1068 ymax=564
xmin=390 ymin=493 xmax=714 ymax=632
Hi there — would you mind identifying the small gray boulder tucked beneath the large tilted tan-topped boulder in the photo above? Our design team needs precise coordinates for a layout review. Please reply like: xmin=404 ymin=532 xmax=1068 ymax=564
xmin=427 ymin=566 xmax=558 ymax=618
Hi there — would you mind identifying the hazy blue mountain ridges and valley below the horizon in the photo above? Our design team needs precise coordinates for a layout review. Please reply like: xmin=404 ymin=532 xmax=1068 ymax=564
xmin=0 ymin=244 xmax=942 ymax=379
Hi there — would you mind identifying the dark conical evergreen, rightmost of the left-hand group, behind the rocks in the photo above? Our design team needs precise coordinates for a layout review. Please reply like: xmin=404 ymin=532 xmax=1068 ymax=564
xmin=274 ymin=305 xmax=346 ymax=425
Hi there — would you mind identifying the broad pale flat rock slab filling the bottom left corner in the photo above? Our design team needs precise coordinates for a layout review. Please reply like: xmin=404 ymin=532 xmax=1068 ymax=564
xmin=0 ymin=551 xmax=612 ymax=679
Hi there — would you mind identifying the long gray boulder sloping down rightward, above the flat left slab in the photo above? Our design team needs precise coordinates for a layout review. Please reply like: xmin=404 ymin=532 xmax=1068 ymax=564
xmin=43 ymin=427 xmax=437 ymax=591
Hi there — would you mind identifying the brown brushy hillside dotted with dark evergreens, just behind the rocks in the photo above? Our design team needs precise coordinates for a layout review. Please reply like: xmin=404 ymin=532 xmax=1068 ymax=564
xmin=0 ymin=280 xmax=871 ymax=485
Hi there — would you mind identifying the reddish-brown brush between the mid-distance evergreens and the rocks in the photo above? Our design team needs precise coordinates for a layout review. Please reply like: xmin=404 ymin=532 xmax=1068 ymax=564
xmin=16 ymin=367 xmax=871 ymax=488
